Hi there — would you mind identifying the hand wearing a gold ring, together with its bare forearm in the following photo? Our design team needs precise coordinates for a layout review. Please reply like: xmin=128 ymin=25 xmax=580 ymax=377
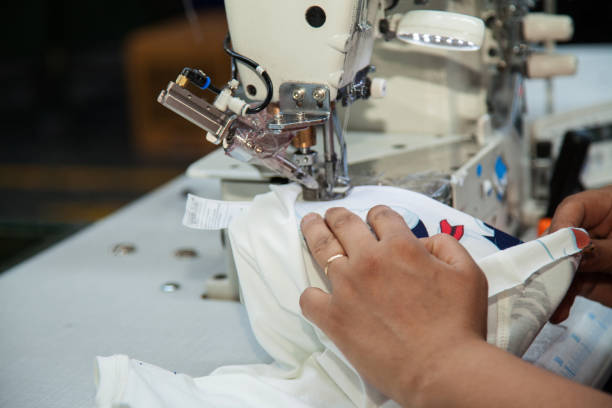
xmin=300 ymin=206 xmax=612 ymax=408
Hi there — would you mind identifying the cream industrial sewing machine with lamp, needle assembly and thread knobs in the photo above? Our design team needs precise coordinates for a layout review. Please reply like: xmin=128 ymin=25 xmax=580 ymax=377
xmin=158 ymin=0 xmax=576 ymax=296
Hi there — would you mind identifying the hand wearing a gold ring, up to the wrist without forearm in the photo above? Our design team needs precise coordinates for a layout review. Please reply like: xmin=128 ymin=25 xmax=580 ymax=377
xmin=300 ymin=206 xmax=487 ymax=405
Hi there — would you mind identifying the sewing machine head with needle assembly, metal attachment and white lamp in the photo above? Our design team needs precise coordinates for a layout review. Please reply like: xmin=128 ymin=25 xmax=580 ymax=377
xmin=158 ymin=0 xmax=484 ymax=200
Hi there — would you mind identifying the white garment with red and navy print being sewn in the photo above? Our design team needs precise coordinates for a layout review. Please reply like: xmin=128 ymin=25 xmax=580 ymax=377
xmin=96 ymin=185 xmax=588 ymax=408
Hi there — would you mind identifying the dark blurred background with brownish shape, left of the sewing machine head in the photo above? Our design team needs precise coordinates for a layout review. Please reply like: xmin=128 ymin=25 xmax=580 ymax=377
xmin=0 ymin=0 xmax=612 ymax=271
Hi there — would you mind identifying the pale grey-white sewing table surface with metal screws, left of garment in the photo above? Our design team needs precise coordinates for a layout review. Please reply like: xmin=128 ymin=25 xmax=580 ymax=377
xmin=0 ymin=177 xmax=269 ymax=408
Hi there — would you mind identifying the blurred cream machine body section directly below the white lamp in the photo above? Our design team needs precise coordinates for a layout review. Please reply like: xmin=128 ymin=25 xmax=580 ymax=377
xmin=349 ymin=40 xmax=487 ymax=136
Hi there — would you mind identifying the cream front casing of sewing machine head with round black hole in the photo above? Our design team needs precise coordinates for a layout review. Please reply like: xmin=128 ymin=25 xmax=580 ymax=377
xmin=225 ymin=0 xmax=382 ymax=102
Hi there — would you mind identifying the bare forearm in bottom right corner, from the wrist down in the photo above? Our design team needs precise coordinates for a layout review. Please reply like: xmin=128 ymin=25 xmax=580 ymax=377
xmin=400 ymin=341 xmax=612 ymax=408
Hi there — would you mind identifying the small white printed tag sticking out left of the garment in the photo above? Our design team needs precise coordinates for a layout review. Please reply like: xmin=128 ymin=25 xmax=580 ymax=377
xmin=183 ymin=194 xmax=251 ymax=230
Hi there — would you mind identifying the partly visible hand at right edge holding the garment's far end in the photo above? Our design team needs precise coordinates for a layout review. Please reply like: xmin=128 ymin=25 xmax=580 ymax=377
xmin=550 ymin=186 xmax=612 ymax=323
